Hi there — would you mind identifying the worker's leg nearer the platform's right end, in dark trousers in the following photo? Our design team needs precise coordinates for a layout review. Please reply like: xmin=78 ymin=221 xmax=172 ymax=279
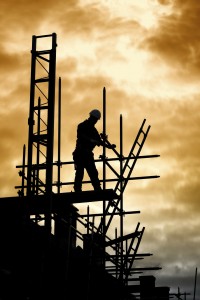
xmin=85 ymin=156 xmax=101 ymax=191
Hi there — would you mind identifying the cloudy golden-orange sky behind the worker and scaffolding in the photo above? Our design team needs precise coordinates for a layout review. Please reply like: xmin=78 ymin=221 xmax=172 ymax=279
xmin=0 ymin=0 xmax=200 ymax=300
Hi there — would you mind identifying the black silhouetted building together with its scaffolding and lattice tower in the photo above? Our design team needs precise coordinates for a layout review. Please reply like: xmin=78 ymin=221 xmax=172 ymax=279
xmin=0 ymin=33 xmax=180 ymax=300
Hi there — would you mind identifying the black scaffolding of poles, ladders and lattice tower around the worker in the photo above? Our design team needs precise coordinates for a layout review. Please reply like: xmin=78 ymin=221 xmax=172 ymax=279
xmin=16 ymin=33 xmax=160 ymax=299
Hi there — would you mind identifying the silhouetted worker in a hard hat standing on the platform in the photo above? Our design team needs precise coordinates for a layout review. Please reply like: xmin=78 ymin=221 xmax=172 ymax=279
xmin=72 ymin=109 xmax=116 ymax=192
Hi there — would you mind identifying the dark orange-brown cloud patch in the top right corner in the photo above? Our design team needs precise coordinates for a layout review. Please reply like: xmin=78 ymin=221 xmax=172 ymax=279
xmin=142 ymin=0 xmax=200 ymax=78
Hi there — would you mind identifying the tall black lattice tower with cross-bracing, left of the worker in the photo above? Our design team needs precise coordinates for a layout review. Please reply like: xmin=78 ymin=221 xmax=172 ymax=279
xmin=21 ymin=33 xmax=57 ymax=230
